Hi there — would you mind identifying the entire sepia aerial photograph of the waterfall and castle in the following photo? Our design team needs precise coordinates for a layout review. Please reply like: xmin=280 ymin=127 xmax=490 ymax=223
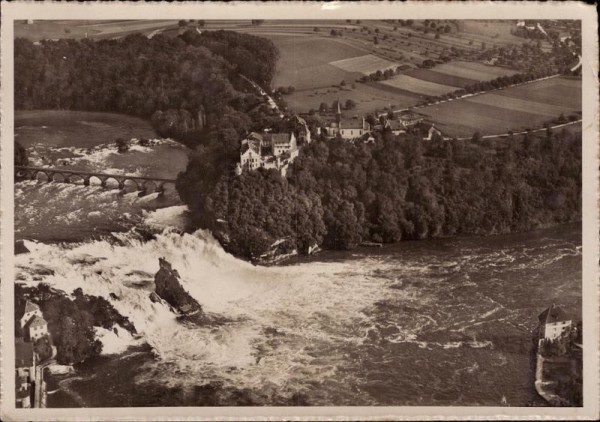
xmin=2 ymin=1 xmax=598 ymax=418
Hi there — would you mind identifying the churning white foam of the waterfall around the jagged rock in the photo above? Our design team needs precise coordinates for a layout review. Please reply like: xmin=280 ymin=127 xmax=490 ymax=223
xmin=16 ymin=227 xmax=390 ymax=396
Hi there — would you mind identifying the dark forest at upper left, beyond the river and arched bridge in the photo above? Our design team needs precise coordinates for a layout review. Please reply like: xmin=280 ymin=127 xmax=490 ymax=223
xmin=15 ymin=31 xmax=278 ymax=146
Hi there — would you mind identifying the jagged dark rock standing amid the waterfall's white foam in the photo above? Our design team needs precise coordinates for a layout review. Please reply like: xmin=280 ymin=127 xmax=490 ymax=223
xmin=151 ymin=258 xmax=202 ymax=315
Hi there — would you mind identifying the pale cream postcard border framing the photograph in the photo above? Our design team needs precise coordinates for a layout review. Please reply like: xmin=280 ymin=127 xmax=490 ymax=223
xmin=0 ymin=2 xmax=600 ymax=420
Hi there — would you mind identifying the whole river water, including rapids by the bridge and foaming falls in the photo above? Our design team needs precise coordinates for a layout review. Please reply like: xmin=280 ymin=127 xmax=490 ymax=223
xmin=16 ymin=110 xmax=582 ymax=407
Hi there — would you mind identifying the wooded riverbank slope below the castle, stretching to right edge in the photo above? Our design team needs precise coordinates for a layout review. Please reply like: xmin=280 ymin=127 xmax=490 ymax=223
xmin=178 ymin=131 xmax=581 ymax=259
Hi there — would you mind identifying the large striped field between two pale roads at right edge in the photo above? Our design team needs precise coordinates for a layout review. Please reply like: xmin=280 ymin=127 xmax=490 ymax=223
xmin=418 ymin=78 xmax=581 ymax=137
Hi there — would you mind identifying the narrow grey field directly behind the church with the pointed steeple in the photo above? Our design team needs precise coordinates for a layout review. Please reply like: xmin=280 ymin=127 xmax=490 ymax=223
xmin=285 ymin=83 xmax=419 ymax=117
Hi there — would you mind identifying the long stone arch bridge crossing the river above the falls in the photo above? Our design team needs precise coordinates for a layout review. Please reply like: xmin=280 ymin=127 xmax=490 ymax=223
xmin=15 ymin=166 xmax=175 ymax=193
